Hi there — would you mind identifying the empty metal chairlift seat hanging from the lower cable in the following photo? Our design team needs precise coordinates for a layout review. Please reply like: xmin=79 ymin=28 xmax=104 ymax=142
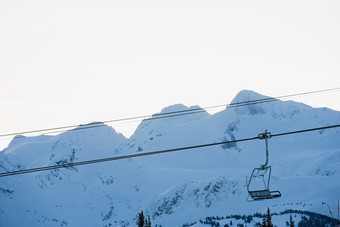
xmin=247 ymin=130 xmax=281 ymax=201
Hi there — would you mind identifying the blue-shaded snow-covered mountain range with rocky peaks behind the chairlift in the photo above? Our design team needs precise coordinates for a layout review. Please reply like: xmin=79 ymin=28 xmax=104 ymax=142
xmin=0 ymin=90 xmax=340 ymax=227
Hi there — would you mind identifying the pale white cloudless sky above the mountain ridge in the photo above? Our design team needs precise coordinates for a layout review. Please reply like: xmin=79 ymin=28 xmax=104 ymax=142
xmin=0 ymin=0 xmax=340 ymax=149
